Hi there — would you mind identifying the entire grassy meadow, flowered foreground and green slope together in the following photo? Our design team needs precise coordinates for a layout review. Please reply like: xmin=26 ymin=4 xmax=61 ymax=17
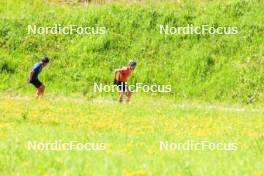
xmin=0 ymin=0 xmax=264 ymax=176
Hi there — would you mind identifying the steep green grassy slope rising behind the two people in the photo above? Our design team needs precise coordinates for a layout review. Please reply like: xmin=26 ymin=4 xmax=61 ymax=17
xmin=0 ymin=0 xmax=264 ymax=103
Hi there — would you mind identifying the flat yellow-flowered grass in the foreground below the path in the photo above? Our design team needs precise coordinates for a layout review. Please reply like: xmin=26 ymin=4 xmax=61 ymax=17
xmin=0 ymin=98 xmax=264 ymax=176
